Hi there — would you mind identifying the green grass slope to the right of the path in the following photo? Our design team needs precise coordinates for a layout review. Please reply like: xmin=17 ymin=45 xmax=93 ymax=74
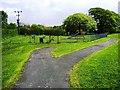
xmin=70 ymin=40 xmax=120 ymax=88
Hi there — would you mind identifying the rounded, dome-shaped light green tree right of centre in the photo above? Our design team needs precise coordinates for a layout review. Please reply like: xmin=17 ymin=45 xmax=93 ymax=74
xmin=63 ymin=13 xmax=96 ymax=34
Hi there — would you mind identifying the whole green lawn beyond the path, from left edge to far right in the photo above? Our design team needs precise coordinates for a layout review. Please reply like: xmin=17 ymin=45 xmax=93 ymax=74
xmin=2 ymin=34 xmax=118 ymax=88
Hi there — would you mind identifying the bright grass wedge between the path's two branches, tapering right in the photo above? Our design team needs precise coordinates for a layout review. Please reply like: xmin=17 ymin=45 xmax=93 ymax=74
xmin=52 ymin=34 xmax=118 ymax=58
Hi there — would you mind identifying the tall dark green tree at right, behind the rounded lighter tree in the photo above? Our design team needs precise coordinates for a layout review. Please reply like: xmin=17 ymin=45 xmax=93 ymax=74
xmin=89 ymin=7 xmax=118 ymax=33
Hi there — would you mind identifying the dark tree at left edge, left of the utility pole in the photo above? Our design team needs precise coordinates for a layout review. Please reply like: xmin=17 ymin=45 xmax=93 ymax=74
xmin=0 ymin=11 xmax=8 ymax=28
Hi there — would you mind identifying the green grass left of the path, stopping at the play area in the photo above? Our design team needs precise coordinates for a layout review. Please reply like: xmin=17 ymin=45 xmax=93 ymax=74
xmin=2 ymin=36 xmax=48 ymax=87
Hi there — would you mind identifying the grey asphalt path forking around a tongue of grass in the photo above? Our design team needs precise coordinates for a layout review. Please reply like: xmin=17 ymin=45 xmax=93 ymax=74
xmin=13 ymin=39 xmax=117 ymax=88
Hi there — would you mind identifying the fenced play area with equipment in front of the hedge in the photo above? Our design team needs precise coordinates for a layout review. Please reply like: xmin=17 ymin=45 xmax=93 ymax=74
xmin=29 ymin=33 xmax=107 ymax=43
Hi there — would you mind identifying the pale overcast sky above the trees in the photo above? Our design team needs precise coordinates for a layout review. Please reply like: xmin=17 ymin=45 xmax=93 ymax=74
xmin=0 ymin=0 xmax=120 ymax=26
